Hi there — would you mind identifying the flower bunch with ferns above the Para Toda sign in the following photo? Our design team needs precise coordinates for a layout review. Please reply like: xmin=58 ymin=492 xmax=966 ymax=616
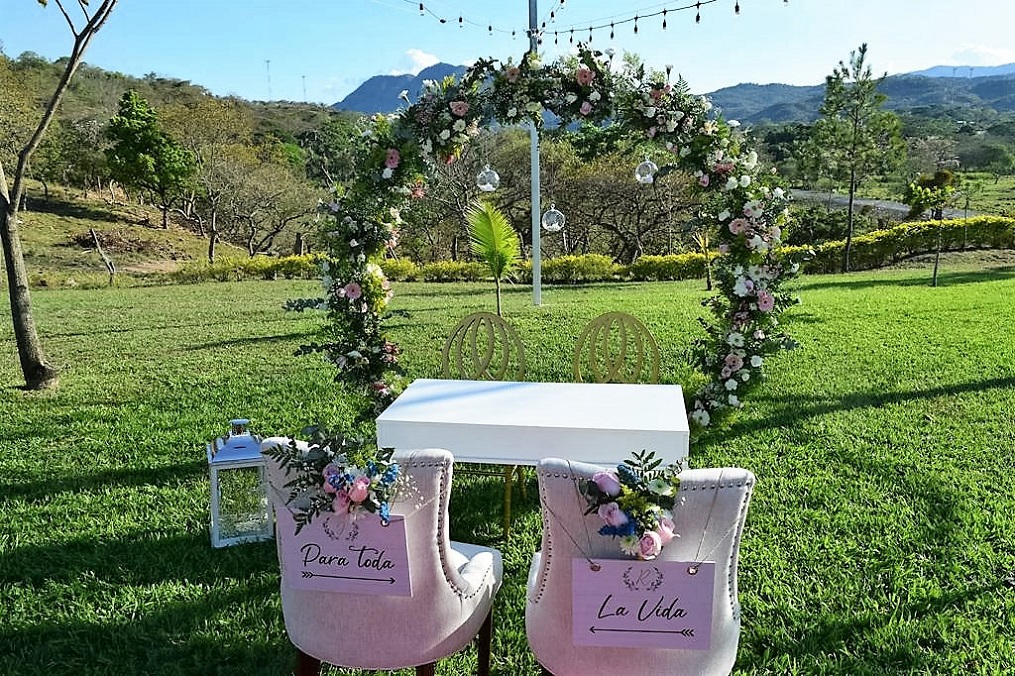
xmin=265 ymin=427 xmax=401 ymax=535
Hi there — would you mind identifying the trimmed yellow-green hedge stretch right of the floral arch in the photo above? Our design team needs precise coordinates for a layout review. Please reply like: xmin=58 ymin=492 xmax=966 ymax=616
xmin=782 ymin=216 xmax=1015 ymax=273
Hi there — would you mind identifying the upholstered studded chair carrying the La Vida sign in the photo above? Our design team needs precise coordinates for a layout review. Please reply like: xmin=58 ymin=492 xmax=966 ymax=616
xmin=525 ymin=459 xmax=754 ymax=676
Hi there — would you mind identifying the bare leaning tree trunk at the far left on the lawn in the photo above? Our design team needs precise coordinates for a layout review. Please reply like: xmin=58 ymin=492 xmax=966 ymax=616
xmin=0 ymin=0 xmax=118 ymax=390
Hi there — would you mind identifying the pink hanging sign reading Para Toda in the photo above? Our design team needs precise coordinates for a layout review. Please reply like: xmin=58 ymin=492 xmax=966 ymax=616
xmin=278 ymin=510 xmax=412 ymax=596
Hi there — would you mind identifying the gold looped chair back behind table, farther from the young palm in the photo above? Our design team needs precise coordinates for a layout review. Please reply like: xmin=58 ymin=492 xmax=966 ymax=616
xmin=573 ymin=312 xmax=659 ymax=383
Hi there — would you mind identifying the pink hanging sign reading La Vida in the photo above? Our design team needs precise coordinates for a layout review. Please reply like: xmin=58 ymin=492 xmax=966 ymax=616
xmin=571 ymin=558 xmax=716 ymax=651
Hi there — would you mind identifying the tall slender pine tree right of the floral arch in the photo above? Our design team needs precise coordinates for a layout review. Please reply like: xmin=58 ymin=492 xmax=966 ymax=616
xmin=810 ymin=44 xmax=905 ymax=272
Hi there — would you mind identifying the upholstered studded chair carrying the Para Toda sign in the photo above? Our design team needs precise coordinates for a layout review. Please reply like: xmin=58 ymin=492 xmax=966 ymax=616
xmin=261 ymin=437 xmax=502 ymax=676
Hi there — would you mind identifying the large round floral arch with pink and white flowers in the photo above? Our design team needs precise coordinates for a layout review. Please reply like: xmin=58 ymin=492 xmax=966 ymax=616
xmin=294 ymin=46 xmax=799 ymax=426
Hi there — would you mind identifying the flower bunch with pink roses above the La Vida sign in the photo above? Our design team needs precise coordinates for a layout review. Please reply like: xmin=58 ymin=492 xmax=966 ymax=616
xmin=582 ymin=451 xmax=680 ymax=561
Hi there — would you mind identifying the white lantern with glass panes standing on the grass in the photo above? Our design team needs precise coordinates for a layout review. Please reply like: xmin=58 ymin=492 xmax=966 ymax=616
xmin=207 ymin=418 xmax=274 ymax=547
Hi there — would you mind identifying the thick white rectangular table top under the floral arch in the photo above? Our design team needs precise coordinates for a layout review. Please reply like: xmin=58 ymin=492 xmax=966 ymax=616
xmin=377 ymin=379 xmax=690 ymax=466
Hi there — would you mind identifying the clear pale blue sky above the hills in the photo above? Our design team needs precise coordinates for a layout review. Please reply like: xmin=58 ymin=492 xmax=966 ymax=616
xmin=0 ymin=0 xmax=1015 ymax=104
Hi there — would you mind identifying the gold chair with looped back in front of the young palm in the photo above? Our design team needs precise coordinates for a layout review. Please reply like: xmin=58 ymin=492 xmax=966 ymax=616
xmin=443 ymin=312 xmax=525 ymax=539
